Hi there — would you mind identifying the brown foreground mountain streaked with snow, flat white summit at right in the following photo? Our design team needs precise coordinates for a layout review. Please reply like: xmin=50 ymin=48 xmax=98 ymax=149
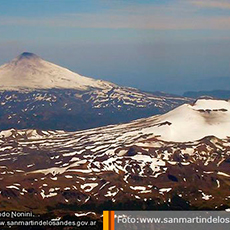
xmin=0 ymin=100 xmax=230 ymax=218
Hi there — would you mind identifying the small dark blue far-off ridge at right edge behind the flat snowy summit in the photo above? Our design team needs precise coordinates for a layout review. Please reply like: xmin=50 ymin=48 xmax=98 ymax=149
xmin=183 ymin=90 xmax=230 ymax=99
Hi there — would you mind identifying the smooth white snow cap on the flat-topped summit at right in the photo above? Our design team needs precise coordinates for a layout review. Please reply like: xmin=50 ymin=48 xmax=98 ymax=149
xmin=143 ymin=99 xmax=230 ymax=142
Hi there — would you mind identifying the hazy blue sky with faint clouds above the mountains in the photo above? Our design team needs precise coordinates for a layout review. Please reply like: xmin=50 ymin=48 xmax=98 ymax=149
xmin=0 ymin=0 xmax=230 ymax=93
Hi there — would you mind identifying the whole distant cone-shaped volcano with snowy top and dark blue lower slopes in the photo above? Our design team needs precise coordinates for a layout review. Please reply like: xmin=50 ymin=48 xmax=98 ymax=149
xmin=0 ymin=52 xmax=192 ymax=131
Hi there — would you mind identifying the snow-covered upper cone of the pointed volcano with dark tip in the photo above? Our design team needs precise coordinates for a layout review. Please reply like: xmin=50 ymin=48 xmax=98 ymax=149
xmin=0 ymin=52 xmax=112 ymax=91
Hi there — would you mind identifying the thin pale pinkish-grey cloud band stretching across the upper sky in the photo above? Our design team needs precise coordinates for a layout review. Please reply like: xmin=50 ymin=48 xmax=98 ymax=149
xmin=0 ymin=0 xmax=230 ymax=30
